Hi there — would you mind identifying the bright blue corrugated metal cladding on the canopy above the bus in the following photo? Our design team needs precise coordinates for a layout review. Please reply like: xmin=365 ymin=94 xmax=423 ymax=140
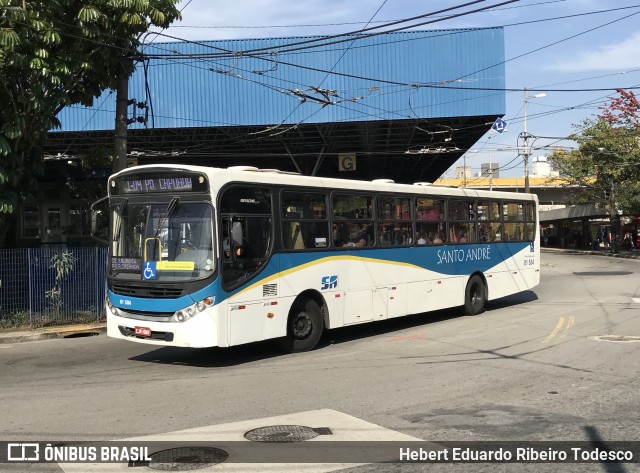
xmin=58 ymin=28 xmax=505 ymax=131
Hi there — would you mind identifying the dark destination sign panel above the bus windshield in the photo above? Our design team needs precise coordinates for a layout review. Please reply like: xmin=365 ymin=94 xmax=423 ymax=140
xmin=111 ymin=174 xmax=208 ymax=194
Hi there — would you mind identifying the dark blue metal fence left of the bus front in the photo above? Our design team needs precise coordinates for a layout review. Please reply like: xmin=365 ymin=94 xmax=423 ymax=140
xmin=0 ymin=248 xmax=107 ymax=327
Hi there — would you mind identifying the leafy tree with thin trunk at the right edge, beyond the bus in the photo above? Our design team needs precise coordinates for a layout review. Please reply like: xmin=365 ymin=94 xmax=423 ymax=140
xmin=552 ymin=90 xmax=640 ymax=250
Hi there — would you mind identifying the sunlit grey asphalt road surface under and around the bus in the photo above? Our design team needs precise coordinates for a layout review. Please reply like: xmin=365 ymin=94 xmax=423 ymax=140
xmin=0 ymin=249 xmax=640 ymax=472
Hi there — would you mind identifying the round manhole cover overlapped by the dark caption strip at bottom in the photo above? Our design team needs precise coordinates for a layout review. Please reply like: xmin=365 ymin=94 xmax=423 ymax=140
xmin=148 ymin=447 xmax=229 ymax=471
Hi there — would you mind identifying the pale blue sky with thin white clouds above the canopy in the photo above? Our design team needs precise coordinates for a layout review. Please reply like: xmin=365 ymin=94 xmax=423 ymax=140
xmin=152 ymin=0 xmax=640 ymax=177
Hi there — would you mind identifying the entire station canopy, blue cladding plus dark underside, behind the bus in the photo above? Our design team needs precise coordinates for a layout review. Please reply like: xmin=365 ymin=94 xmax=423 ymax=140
xmin=45 ymin=28 xmax=505 ymax=183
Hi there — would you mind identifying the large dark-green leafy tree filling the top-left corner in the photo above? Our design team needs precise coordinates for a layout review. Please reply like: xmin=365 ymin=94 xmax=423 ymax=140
xmin=0 ymin=0 xmax=180 ymax=245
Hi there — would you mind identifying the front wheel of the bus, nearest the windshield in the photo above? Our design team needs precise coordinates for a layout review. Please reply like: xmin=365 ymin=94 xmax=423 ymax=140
xmin=285 ymin=298 xmax=324 ymax=353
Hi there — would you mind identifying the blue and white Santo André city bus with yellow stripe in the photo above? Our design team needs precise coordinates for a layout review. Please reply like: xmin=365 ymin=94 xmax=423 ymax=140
xmin=100 ymin=165 xmax=540 ymax=351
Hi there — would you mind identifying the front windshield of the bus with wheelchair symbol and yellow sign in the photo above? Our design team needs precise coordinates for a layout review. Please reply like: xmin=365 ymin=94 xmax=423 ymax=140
xmin=109 ymin=198 xmax=215 ymax=282
